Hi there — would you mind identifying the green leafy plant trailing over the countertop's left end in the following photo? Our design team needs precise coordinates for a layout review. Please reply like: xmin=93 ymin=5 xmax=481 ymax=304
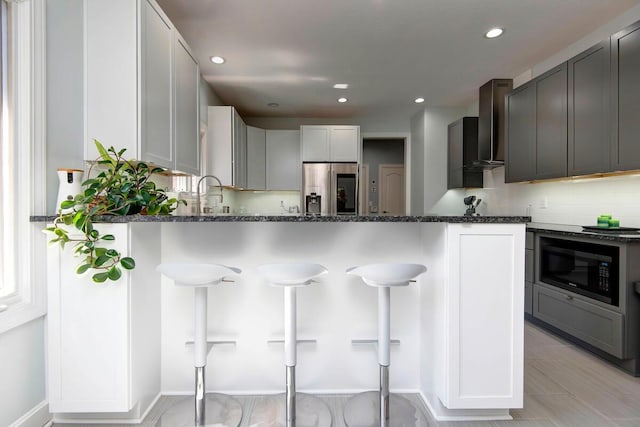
xmin=45 ymin=140 xmax=186 ymax=283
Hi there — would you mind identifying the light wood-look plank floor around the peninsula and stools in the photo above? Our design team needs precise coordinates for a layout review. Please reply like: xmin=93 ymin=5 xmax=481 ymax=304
xmin=55 ymin=322 xmax=640 ymax=427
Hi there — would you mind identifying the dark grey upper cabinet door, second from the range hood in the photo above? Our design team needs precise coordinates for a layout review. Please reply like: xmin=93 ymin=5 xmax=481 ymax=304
xmin=536 ymin=63 xmax=567 ymax=179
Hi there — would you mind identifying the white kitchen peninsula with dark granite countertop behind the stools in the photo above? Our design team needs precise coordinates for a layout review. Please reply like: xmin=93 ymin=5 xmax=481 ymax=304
xmin=37 ymin=215 xmax=530 ymax=422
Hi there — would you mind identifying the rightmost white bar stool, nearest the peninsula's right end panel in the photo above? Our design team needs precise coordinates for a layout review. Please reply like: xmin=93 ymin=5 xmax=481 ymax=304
xmin=344 ymin=264 xmax=427 ymax=427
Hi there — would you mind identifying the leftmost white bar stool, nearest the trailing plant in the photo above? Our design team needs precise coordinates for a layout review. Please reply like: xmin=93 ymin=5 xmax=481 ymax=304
xmin=156 ymin=263 xmax=242 ymax=427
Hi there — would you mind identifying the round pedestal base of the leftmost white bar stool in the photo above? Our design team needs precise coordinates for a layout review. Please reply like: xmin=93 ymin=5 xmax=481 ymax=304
xmin=155 ymin=393 xmax=242 ymax=427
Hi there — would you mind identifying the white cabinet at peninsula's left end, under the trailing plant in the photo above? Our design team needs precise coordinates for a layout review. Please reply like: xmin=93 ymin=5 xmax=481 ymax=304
xmin=47 ymin=223 xmax=161 ymax=422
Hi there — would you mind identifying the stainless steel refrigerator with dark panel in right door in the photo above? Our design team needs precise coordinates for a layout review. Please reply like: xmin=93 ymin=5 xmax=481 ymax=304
xmin=301 ymin=163 xmax=358 ymax=215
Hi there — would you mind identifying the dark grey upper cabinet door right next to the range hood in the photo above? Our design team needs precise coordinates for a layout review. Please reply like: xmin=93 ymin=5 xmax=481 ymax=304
xmin=505 ymin=82 xmax=536 ymax=182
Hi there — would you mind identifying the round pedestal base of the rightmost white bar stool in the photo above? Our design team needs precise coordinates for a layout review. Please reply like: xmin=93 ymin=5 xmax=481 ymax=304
xmin=344 ymin=391 xmax=428 ymax=427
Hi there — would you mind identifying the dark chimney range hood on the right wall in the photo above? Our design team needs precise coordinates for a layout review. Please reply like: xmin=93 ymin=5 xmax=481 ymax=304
xmin=472 ymin=79 xmax=513 ymax=169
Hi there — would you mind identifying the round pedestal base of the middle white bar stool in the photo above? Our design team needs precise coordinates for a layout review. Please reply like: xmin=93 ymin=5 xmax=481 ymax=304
xmin=249 ymin=393 xmax=332 ymax=427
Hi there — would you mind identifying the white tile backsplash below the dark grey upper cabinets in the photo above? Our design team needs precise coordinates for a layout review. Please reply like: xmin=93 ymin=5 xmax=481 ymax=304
xmin=468 ymin=167 xmax=640 ymax=227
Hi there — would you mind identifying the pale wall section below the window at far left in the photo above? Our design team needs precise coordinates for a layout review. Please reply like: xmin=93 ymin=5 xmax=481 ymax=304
xmin=0 ymin=318 xmax=46 ymax=426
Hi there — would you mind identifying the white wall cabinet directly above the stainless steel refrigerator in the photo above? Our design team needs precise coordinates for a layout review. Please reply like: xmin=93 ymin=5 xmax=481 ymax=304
xmin=300 ymin=125 xmax=360 ymax=162
